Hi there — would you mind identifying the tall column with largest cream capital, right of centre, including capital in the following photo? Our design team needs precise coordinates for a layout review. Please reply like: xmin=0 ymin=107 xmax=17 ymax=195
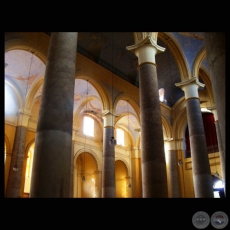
xmin=127 ymin=33 xmax=168 ymax=198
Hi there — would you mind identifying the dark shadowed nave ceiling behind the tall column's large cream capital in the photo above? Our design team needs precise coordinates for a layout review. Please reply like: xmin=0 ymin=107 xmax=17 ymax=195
xmin=45 ymin=32 xmax=202 ymax=107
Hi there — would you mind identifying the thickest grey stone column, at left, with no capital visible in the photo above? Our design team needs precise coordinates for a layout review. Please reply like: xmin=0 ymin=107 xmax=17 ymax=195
xmin=30 ymin=32 xmax=77 ymax=198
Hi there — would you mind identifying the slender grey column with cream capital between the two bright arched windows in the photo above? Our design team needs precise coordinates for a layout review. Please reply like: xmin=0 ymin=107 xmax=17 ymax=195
xmin=102 ymin=111 xmax=116 ymax=198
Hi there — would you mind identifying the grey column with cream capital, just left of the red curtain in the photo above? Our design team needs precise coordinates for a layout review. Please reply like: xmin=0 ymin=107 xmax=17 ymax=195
xmin=176 ymin=78 xmax=213 ymax=198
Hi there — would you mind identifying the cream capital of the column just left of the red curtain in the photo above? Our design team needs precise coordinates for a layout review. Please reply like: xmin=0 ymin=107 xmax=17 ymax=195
xmin=175 ymin=77 xmax=205 ymax=99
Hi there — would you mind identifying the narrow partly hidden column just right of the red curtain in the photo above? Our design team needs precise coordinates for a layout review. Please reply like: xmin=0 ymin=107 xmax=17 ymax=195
xmin=207 ymin=106 xmax=226 ymax=197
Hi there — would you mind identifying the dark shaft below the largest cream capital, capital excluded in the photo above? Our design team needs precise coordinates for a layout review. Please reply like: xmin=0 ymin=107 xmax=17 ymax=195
xmin=139 ymin=63 xmax=168 ymax=198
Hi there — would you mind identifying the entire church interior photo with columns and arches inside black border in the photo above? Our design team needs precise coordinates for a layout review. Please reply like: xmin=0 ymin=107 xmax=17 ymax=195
xmin=4 ymin=32 xmax=226 ymax=198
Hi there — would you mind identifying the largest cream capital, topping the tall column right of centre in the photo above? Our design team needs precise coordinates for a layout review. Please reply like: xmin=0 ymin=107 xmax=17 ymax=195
xmin=126 ymin=34 xmax=165 ymax=65
